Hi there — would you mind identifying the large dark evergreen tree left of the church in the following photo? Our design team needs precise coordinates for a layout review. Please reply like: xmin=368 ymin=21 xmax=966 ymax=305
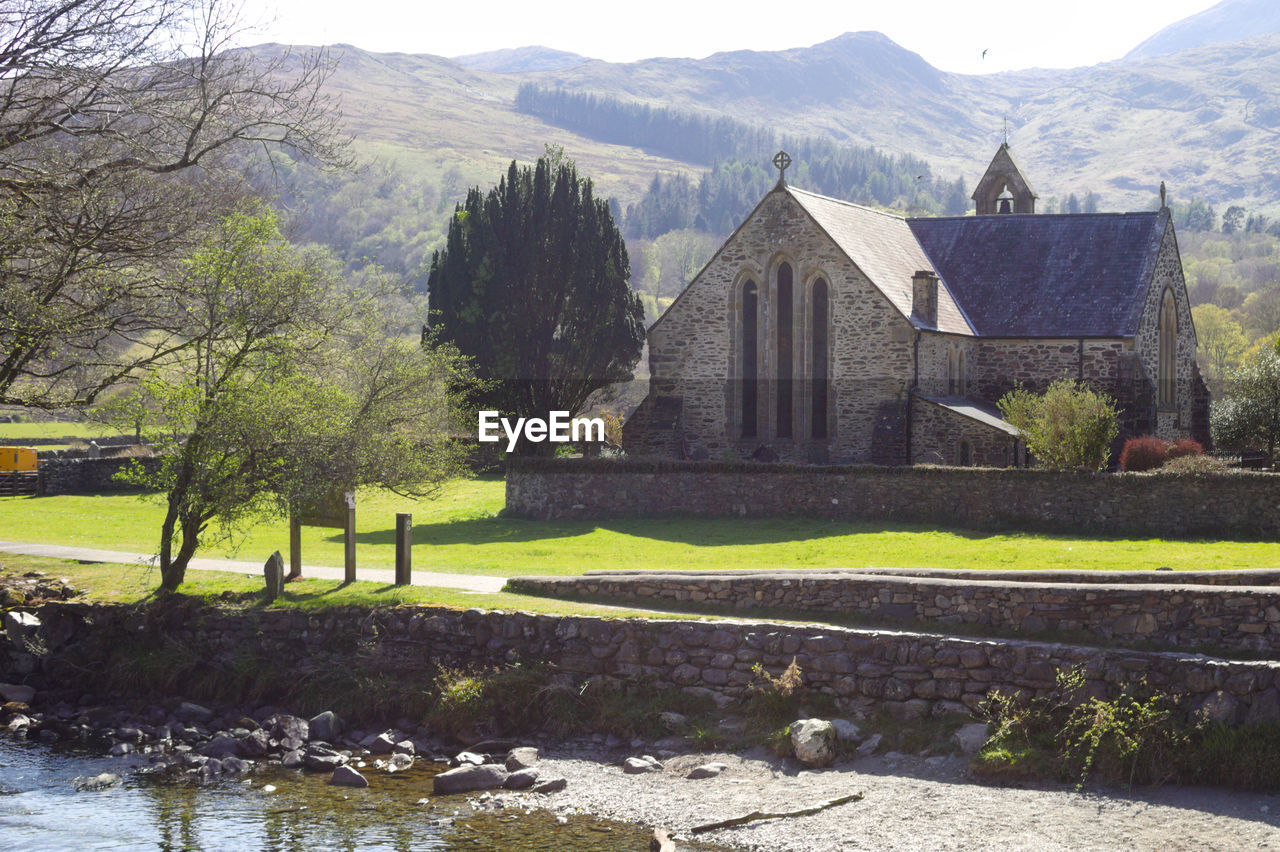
xmin=428 ymin=151 xmax=644 ymax=437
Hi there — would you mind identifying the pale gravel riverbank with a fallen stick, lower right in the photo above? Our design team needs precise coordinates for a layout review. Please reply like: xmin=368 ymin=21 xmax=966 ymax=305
xmin=522 ymin=750 xmax=1280 ymax=852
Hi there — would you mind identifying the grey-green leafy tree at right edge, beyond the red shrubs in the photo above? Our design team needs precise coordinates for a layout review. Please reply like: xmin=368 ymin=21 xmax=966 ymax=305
xmin=1210 ymin=347 xmax=1280 ymax=463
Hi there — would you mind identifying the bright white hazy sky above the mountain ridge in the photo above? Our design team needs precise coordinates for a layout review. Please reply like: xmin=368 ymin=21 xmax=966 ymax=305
xmin=248 ymin=0 xmax=1217 ymax=74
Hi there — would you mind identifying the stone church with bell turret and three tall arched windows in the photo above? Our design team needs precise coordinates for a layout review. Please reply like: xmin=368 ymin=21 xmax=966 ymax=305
xmin=623 ymin=143 xmax=1208 ymax=467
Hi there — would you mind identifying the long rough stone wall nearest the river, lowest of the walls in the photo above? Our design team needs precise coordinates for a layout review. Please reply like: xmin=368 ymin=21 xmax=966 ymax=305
xmin=15 ymin=603 xmax=1280 ymax=723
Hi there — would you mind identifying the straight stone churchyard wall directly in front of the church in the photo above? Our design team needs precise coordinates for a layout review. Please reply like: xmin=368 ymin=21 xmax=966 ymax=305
xmin=507 ymin=459 xmax=1280 ymax=539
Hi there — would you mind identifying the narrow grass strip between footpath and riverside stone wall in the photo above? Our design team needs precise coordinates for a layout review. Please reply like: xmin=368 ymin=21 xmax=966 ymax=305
xmin=0 ymin=554 xmax=689 ymax=618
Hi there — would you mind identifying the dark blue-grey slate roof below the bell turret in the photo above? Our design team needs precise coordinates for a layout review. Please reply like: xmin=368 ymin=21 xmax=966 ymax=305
xmin=906 ymin=212 xmax=1167 ymax=338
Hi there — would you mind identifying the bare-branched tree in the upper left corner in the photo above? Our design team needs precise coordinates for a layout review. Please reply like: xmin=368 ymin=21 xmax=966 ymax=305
xmin=0 ymin=0 xmax=347 ymax=408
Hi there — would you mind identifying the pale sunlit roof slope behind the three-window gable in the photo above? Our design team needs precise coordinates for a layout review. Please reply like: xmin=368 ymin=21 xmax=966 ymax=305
xmin=786 ymin=187 xmax=973 ymax=335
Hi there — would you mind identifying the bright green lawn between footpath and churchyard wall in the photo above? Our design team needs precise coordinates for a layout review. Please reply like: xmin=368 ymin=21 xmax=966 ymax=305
xmin=0 ymin=470 xmax=1280 ymax=576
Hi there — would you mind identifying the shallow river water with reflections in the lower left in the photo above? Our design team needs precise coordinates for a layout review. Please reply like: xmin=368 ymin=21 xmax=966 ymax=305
xmin=0 ymin=738 xmax=722 ymax=852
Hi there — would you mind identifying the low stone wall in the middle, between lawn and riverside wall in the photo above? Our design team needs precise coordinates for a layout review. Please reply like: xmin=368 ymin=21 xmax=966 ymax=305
xmin=508 ymin=572 xmax=1280 ymax=654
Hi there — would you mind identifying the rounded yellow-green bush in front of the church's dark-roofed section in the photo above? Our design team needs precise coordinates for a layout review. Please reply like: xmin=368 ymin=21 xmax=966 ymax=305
xmin=997 ymin=379 xmax=1120 ymax=471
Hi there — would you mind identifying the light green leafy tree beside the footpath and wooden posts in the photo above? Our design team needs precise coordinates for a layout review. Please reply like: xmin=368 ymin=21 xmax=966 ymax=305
xmin=119 ymin=207 xmax=471 ymax=591
